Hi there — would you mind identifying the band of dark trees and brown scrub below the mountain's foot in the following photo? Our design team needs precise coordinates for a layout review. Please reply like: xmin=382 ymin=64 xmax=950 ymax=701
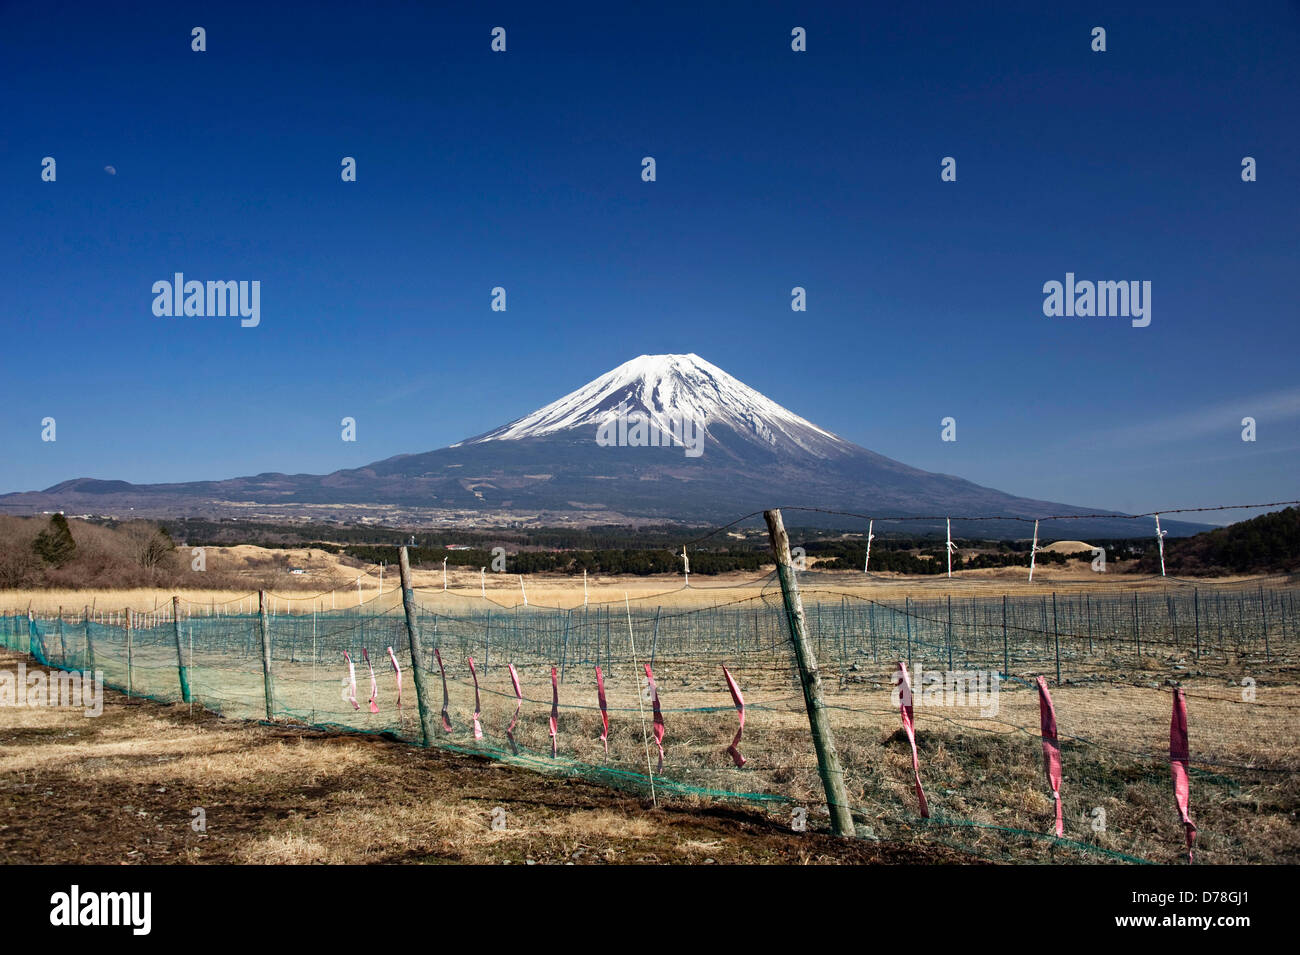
xmin=0 ymin=508 xmax=1300 ymax=589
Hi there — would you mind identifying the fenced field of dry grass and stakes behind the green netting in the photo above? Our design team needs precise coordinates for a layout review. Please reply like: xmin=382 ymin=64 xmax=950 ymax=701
xmin=12 ymin=574 xmax=1300 ymax=861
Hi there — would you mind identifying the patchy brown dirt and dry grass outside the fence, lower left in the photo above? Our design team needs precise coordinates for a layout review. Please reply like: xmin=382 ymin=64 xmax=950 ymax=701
xmin=0 ymin=654 xmax=975 ymax=864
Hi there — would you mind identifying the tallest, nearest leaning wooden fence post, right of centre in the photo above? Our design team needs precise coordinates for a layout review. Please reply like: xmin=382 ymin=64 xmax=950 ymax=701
xmin=763 ymin=511 xmax=854 ymax=835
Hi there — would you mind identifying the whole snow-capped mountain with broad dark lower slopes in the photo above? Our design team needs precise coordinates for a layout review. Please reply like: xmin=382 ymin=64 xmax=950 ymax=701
xmin=0 ymin=355 xmax=1203 ymax=537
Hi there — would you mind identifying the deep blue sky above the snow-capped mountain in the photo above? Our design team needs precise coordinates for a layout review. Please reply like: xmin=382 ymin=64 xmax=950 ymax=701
xmin=0 ymin=1 xmax=1300 ymax=518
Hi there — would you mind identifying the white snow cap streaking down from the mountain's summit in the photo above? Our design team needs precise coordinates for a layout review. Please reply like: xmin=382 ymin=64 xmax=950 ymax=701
xmin=452 ymin=355 xmax=853 ymax=457
